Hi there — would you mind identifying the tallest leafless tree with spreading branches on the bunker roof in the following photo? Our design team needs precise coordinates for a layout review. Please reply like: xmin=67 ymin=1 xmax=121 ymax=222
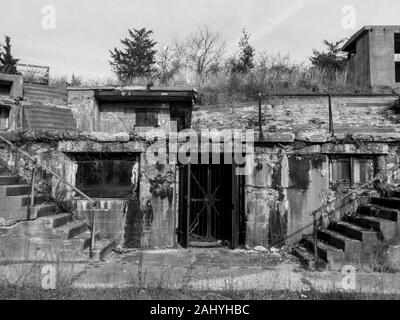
xmin=186 ymin=24 xmax=225 ymax=84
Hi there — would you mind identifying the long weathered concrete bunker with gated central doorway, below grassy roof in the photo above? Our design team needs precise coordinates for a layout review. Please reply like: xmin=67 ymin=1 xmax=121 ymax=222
xmin=0 ymin=70 xmax=400 ymax=270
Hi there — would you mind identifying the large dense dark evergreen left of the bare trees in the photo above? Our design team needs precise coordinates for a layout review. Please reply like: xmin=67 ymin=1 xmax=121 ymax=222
xmin=110 ymin=28 xmax=157 ymax=81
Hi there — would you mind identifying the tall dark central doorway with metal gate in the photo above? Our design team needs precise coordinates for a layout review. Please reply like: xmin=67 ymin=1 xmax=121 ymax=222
xmin=178 ymin=164 xmax=244 ymax=248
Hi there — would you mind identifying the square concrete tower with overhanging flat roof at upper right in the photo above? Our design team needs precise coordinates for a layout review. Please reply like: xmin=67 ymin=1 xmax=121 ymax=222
xmin=343 ymin=26 xmax=400 ymax=92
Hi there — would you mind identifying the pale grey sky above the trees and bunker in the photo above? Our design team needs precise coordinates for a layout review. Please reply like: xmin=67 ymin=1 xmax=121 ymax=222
xmin=0 ymin=0 xmax=400 ymax=79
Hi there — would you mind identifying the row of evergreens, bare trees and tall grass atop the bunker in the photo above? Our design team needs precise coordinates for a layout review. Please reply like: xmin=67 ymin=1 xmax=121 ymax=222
xmin=110 ymin=24 xmax=361 ymax=104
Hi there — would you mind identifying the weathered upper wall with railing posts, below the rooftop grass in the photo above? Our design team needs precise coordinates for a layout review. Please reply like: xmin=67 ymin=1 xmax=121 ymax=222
xmin=192 ymin=96 xmax=400 ymax=138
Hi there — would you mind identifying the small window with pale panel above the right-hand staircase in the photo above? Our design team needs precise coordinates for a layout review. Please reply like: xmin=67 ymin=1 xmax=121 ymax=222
xmin=330 ymin=156 xmax=376 ymax=188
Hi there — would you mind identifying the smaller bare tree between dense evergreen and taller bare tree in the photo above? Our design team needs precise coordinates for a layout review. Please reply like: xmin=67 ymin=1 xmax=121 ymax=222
xmin=157 ymin=39 xmax=185 ymax=84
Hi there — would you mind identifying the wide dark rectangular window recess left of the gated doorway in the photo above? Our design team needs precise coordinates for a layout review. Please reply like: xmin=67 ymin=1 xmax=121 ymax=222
xmin=76 ymin=155 xmax=136 ymax=198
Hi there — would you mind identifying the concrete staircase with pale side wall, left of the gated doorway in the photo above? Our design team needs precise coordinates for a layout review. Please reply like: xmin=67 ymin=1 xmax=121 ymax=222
xmin=0 ymin=176 xmax=116 ymax=261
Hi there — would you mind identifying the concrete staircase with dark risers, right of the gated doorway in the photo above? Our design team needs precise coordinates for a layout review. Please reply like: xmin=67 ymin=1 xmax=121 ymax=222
xmin=293 ymin=191 xmax=400 ymax=270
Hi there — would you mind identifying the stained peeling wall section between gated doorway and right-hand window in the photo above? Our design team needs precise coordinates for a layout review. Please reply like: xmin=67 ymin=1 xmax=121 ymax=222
xmin=245 ymin=148 xmax=328 ymax=247
